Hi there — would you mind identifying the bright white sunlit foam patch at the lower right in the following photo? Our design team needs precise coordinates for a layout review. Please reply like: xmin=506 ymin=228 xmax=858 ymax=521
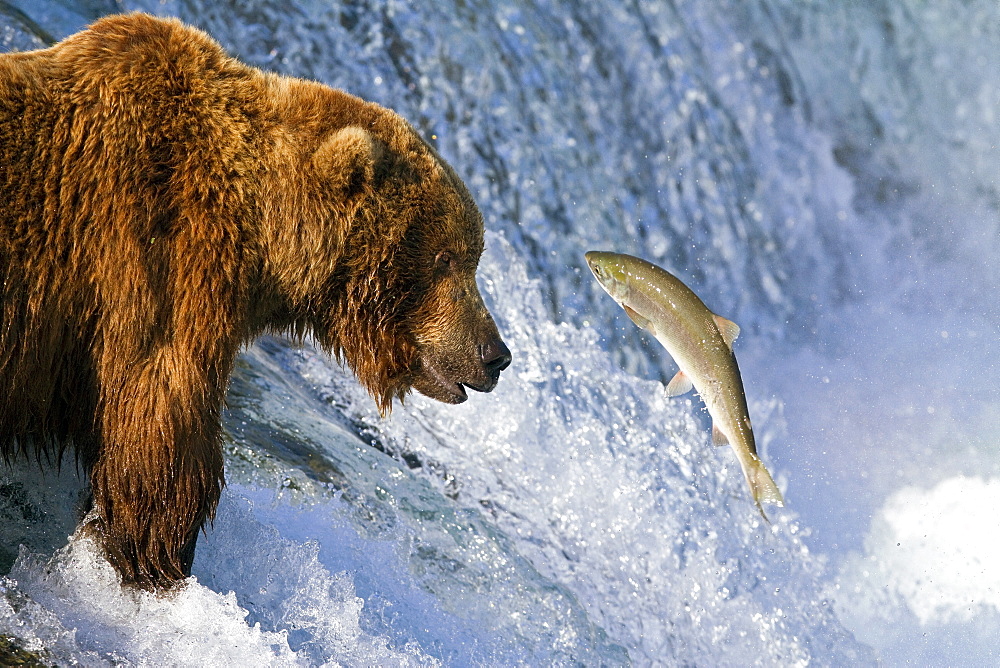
xmin=830 ymin=476 xmax=1000 ymax=665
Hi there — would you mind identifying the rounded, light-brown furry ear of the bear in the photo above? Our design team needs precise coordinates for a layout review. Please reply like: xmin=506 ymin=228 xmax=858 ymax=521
xmin=312 ymin=126 xmax=375 ymax=200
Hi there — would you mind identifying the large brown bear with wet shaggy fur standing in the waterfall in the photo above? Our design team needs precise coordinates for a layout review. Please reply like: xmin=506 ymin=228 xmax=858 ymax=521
xmin=0 ymin=14 xmax=510 ymax=587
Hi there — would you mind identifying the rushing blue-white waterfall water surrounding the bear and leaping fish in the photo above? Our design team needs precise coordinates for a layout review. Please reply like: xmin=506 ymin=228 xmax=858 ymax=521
xmin=0 ymin=0 xmax=1000 ymax=666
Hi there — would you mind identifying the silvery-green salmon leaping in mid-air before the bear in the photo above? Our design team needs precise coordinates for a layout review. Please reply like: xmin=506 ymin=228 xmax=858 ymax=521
xmin=586 ymin=251 xmax=784 ymax=520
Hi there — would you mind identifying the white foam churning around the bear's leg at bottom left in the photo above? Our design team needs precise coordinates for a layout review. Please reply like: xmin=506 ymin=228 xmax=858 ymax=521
xmin=0 ymin=485 xmax=454 ymax=666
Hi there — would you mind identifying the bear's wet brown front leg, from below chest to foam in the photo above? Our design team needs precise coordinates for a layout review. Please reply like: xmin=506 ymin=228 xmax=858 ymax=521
xmin=91 ymin=351 xmax=226 ymax=588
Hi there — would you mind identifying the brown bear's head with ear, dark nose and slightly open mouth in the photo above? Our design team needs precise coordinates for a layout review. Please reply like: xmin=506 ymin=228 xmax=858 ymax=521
xmin=268 ymin=117 xmax=511 ymax=413
